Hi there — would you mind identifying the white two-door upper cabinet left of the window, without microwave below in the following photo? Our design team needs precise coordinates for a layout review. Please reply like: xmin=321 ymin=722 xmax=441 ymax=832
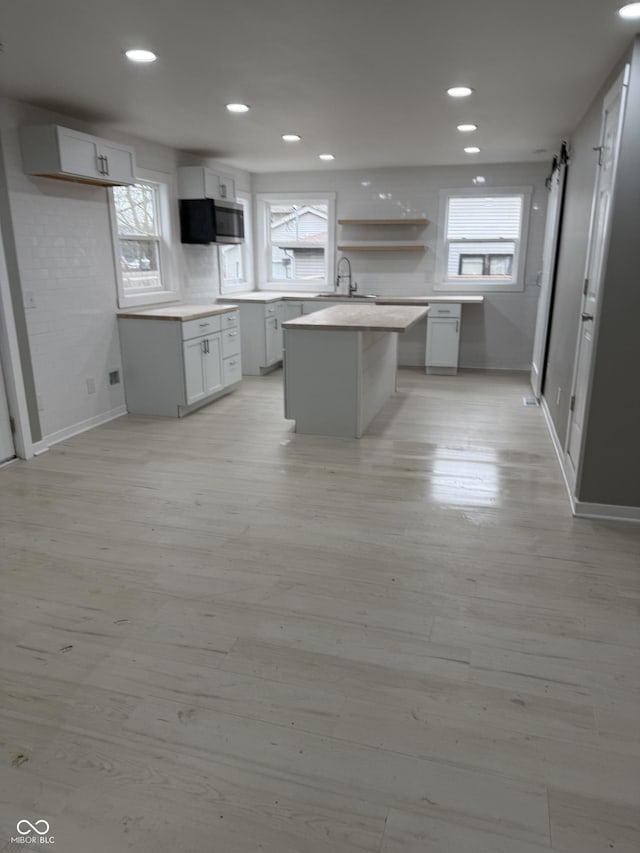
xmin=20 ymin=124 xmax=136 ymax=187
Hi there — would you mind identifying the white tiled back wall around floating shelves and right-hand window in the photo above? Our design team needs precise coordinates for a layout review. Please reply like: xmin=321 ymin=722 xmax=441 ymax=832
xmin=253 ymin=163 xmax=550 ymax=370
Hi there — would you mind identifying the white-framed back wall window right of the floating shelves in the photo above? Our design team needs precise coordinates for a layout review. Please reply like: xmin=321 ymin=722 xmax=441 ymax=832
xmin=436 ymin=189 xmax=531 ymax=291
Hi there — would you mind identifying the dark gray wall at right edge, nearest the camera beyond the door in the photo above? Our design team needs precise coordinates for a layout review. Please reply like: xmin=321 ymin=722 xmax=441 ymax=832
xmin=578 ymin=37 xmax=640 ymax=506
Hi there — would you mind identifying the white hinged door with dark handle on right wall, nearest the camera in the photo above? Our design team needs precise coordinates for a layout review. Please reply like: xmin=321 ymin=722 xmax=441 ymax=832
xmin=565 ymin=70 xmax=627 ymax=487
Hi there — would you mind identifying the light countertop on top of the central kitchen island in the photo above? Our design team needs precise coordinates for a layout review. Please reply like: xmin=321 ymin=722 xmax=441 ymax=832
xmin=282 ymin=302 xmax=429 ymax=332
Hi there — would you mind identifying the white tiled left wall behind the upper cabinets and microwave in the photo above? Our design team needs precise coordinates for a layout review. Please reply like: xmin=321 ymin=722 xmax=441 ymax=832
xmin=0 ymin=95 xmax=251 ymax=444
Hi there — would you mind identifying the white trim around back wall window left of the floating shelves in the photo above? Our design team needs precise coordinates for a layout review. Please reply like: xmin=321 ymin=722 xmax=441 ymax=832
xmin=255 ymin=190 xmax=336 ymax=293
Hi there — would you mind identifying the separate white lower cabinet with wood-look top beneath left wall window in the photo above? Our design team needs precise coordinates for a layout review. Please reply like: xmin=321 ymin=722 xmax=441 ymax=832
xmin=118 ymin=310 xmax=242 ymax=417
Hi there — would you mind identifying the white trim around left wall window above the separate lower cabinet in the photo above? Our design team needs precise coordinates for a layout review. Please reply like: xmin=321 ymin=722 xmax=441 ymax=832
xmin=109 ymin=169 xmax=182 ymax=308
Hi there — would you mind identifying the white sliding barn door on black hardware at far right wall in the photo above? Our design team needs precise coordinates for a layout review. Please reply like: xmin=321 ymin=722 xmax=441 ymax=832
xmin=531 ymin=145 xmax=567 ymax=398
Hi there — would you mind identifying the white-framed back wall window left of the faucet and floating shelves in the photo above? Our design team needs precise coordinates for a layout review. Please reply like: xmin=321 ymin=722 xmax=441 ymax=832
xmin=258 ymin=193 xmax=335 ymax=291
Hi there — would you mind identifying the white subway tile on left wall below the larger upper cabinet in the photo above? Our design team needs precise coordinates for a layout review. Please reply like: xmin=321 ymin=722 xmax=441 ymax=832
xmin=11 ymin=187 xmax=124 ymax=438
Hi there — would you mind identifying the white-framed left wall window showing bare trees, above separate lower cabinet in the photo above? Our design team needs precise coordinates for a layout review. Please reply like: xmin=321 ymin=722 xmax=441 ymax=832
xmin=111 ymin=168 xmax=178 ymax=307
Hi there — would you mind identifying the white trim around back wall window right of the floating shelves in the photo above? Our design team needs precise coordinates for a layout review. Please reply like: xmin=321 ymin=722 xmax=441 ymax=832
xmin=434 ymin=186 xmax=533 ymax=293
